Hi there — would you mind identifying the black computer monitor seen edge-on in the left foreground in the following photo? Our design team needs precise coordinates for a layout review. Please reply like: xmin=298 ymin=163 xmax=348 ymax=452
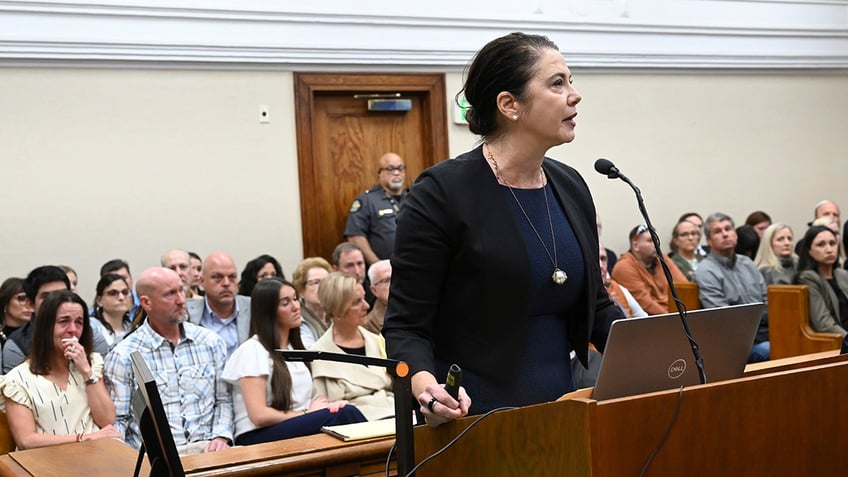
xmin=130 ymin=351 xmax=185 ymax=477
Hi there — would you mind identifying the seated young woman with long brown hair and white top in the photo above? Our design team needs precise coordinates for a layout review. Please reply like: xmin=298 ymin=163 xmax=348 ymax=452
xmin=222 ymin=277 xmax=365 ymax=445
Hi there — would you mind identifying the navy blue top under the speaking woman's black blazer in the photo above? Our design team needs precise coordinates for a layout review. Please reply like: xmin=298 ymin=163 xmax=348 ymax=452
xmin=437 ymin=185 xmax=584 ymax=414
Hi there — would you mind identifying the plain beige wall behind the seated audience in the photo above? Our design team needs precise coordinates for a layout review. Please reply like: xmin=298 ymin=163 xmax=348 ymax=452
xmin=0 ymin=68 xmax=848 ymax=300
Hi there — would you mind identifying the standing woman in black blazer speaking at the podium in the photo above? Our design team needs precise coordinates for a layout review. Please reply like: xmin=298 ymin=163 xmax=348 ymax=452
xmin=383 ymin=33 xmax=623 ymax=425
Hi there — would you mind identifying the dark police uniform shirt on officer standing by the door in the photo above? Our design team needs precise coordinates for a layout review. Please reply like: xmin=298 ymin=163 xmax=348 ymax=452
xmin=344 ymin=184 xmax=406 ymax=259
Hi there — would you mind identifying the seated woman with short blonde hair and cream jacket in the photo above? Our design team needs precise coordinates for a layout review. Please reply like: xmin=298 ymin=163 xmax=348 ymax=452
xmin=310 ymin=272 xmax=395 ymax=420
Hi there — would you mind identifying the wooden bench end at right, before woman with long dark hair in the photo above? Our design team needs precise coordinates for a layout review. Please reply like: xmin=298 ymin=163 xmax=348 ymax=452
xmin=768 ymin=285 xmax=842 ymax=359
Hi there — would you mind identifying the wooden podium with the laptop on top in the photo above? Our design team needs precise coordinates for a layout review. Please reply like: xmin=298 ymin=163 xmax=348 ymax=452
xmin=415 ymin=356 xmax=848 ymax=477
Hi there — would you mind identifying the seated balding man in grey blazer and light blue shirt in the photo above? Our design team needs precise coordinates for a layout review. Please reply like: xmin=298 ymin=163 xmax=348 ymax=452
xmin=186 ymin=252 xmax=250 ymax=356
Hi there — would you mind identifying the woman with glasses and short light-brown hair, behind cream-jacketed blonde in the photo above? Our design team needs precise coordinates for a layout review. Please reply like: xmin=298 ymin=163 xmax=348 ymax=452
xmin=292 ymin=257 xmax=333 ymax=348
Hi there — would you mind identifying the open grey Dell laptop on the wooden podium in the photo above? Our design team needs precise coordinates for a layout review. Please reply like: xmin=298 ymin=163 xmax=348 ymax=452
xmin=592 ymin=303 xmax=765 ymax=401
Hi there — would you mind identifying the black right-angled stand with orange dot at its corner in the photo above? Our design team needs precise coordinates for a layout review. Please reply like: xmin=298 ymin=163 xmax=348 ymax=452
xmin=274 ymin=349 xmax=415 ymax=476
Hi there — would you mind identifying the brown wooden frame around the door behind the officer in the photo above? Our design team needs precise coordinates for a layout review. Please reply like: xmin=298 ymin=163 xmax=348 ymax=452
xmin=294 ymin=73 xmax=450 ymax=259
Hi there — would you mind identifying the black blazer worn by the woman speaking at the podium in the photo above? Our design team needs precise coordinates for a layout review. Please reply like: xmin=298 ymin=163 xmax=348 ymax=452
xmin=383 ymin=146 xmax=624 ymax=379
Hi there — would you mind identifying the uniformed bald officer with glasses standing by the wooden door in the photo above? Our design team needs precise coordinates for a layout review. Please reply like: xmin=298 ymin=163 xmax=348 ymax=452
xmin=344 ymin=152 xmax=406 ymax=265
